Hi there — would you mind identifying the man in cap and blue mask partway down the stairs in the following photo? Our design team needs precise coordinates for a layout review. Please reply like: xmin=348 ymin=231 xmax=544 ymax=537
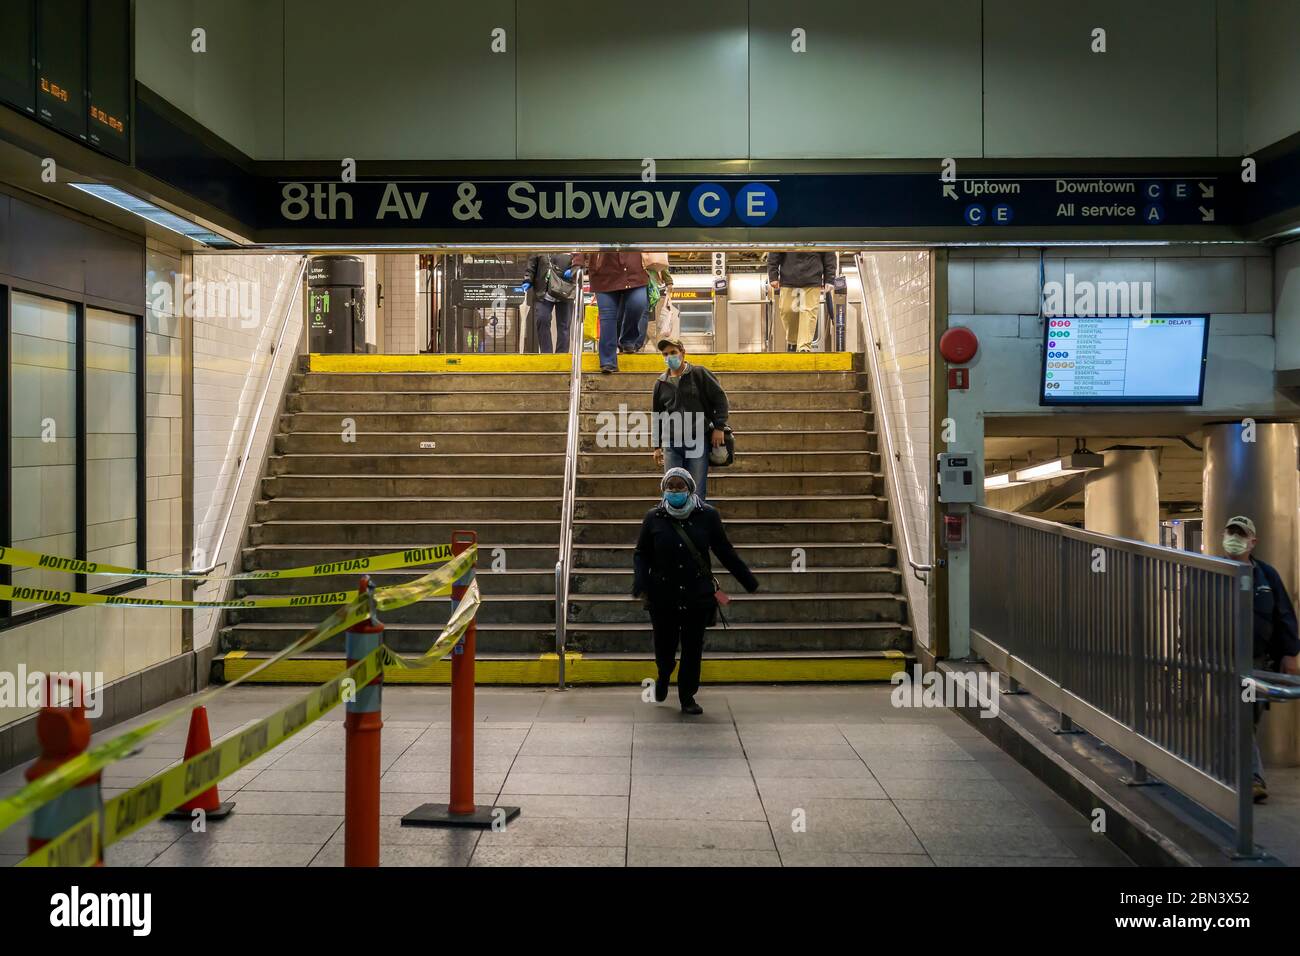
xmin=651 ymin=338 xmax=729 ymax=501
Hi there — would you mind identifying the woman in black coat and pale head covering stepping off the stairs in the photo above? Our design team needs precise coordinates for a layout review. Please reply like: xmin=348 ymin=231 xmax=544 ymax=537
xmin=632 ymin=468 xmax=758 ymax=714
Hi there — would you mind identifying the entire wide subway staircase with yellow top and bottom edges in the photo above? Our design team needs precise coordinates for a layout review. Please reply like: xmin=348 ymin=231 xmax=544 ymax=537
xmin=213 ymin=355 xmax=911 ymax=684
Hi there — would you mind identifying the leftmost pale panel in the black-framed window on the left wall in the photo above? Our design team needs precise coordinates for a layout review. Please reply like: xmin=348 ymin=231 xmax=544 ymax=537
xmin=9 ymin=293 xmax=77 ymax=614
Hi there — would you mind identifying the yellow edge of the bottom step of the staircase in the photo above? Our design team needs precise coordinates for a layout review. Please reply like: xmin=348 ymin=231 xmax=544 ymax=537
xmin=218 ymin=652 xmax=905 ymax=684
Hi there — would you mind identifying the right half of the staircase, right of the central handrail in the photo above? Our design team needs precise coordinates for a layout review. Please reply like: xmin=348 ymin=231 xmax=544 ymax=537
xmin=568 ymin=355 xmax=911 ymax=680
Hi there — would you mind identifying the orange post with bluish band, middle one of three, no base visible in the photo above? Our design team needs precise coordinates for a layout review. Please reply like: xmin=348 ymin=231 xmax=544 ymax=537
xmin=343 ymin=575 xmax=384 ymax=866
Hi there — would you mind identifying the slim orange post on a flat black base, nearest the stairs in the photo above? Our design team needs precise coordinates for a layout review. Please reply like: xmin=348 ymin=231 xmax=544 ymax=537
xmin=402 ymin=531 xmax=519 ymax=829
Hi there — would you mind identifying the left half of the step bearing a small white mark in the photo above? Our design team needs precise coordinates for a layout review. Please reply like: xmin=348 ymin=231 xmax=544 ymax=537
xmin=276 ymin=429 xmax=566 ymax=457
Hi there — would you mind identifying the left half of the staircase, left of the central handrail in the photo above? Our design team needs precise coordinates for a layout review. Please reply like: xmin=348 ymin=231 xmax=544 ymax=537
xmin=218 ymin=356 xmax=569 ymax=676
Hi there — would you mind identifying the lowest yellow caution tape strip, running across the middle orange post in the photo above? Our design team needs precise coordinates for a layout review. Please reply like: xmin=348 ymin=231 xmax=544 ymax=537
xmin=18 ymin=564 xmax=481 ymax=866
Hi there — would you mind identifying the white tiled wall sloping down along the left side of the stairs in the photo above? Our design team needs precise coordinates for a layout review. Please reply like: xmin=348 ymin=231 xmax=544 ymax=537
xmin=194 ymin=255 xmax=303 ymax=649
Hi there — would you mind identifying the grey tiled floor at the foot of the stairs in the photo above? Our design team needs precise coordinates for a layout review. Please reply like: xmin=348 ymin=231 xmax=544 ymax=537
xmin=0 ymin=685 xmax=1130 ymax=866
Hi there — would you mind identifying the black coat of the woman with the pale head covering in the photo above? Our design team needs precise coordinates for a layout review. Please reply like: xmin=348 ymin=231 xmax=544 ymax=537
xmin=632 ymin=503 xmax=758 ymax=610
